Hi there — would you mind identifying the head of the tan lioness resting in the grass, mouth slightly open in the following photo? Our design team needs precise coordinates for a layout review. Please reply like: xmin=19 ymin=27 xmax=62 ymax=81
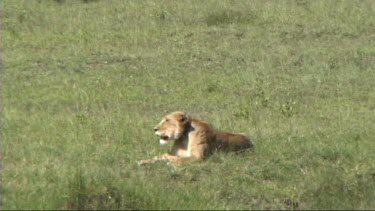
xmin=154 ymin=111 xmax=191 ymax=145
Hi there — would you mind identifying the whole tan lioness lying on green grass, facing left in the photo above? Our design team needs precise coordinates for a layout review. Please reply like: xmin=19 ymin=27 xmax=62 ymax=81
xmin=138 ymin=111 xmax=253 ymax=165
